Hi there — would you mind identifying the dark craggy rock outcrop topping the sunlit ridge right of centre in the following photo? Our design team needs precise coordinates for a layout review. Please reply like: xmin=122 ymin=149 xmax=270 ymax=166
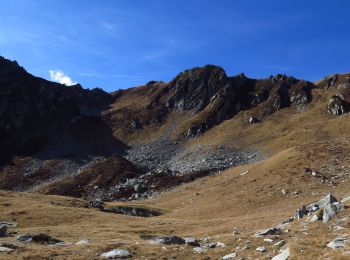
xmin=166 ymin=65 xmax=313 ymax=138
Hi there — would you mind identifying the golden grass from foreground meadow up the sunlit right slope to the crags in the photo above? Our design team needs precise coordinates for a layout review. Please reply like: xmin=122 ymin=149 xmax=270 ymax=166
xmin=0 ymin=77 xmax=350 ymax=259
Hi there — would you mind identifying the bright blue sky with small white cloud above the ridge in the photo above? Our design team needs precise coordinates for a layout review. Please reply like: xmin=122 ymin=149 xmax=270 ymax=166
xmin=0 ymin=0 xmax=350 ymax=91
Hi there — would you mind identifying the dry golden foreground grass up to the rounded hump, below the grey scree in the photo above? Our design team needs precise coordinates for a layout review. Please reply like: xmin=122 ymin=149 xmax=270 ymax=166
xmin=0 ymin=144 xmax=350 ymax=259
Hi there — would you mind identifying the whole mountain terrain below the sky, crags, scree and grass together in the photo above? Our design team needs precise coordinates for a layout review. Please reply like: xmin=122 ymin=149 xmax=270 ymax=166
xmin=0 ymin=58 xmax=350 ymax=260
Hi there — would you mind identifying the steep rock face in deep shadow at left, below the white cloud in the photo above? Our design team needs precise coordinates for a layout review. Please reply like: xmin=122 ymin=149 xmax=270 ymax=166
xmin=0 ymin=55 xmax=113 ymax=159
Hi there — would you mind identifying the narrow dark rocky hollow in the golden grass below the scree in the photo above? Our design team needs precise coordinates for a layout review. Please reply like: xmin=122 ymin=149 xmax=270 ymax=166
xmin=103 ymin=206 xmax=163 ymax=218
